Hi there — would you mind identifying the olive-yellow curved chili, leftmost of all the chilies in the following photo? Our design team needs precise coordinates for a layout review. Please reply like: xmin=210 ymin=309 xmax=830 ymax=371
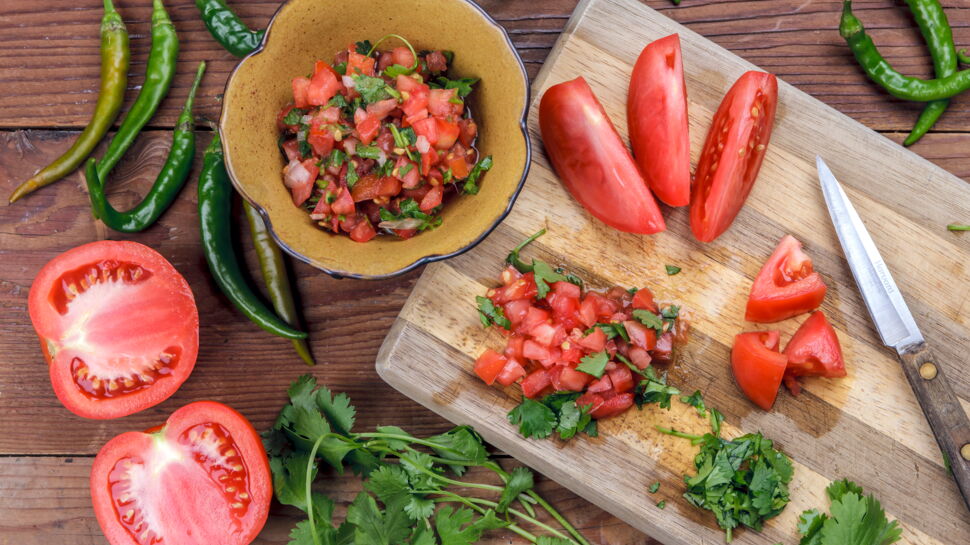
xmin=10 ymin=0 xmax=130 ymax=202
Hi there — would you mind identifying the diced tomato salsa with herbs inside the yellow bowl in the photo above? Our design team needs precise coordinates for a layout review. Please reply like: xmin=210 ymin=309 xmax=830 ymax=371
xmin=277 ymin=39 xmax=492 ymax=242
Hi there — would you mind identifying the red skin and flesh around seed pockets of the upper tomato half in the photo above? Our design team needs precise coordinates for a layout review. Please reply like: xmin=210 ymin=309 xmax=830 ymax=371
xmin=28 ymin=240 xmax=199 ymax=420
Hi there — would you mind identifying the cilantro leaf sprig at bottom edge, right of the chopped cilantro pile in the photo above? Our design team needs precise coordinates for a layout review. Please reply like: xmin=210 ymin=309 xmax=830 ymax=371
xmin=798 ymin=479 xmax=902 ymax=545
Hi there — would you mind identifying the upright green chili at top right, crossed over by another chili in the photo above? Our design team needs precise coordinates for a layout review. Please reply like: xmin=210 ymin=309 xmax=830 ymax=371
xmin=903 ymin=0 xmax=958 ymax=146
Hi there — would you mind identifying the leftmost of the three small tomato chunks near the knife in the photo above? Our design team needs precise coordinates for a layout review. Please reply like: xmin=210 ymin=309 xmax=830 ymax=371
xmin=731 ymin=331 xmax=788 ymax=411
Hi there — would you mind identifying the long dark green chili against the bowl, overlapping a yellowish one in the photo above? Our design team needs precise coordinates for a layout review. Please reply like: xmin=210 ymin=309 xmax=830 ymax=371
xmin=199 ymin=132 xmax=306 ymax=339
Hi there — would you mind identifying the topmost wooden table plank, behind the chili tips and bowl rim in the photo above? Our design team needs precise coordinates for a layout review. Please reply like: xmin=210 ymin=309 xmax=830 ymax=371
xmin=0 ymin=0 xmax=970 ymax=131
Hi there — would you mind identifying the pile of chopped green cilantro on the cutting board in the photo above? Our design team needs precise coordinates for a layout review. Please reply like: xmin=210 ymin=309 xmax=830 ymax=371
xmin=657 ymin=410 xmax=792 ymax=545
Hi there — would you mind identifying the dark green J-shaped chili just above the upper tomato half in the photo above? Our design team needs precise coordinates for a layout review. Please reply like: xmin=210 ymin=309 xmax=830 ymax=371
xmin=85 ymin=61 xmax=205 ymax=233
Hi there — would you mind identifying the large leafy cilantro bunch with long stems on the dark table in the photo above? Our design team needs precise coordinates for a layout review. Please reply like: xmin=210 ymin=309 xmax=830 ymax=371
xmin=263 ymin=375 xmax=589 ymax=545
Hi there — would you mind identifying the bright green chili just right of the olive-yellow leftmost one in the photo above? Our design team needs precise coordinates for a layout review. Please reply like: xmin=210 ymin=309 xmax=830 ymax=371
xmin=98 ymin=0 xmax=179 ymax=180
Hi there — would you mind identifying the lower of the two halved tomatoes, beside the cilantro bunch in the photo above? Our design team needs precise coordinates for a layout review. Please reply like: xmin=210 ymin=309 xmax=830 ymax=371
xmin=91 ymin=401 xmax=273 ymax=545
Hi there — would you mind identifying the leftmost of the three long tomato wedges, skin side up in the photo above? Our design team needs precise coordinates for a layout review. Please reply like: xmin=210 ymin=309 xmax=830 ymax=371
xmin=539 ymin=77 xmax=666 ymax=234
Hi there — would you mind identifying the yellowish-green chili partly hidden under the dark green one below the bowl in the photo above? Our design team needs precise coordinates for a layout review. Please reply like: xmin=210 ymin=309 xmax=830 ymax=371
xmin=243 ymin=200 xmax=317 ymax=365
